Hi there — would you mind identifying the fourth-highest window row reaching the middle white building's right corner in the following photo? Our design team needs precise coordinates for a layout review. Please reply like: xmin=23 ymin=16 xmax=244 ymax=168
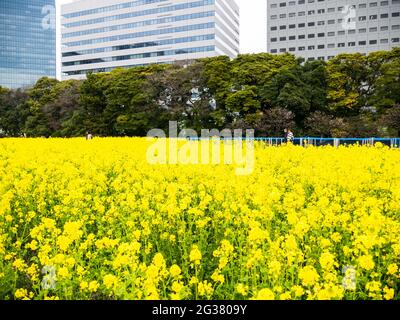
xmin=62 ymin=34 xmax=215 ymax=57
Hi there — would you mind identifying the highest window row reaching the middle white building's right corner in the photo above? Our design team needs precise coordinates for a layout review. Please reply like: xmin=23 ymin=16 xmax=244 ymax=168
xmin=64 ymin=0 xmax=215 ymax=28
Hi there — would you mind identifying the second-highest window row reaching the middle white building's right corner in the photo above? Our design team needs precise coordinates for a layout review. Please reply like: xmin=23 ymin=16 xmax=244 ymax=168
xmin=62 ymin=11 xmax=215 ymax=38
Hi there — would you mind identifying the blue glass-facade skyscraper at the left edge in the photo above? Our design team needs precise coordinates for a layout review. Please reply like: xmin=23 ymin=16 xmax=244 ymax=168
xmin=0 ymin=0 xmax=56 ymax=88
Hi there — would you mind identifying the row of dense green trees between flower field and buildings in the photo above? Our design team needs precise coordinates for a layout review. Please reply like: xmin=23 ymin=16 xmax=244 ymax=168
xmin=0 ymin=48 xmax=400 ymax=137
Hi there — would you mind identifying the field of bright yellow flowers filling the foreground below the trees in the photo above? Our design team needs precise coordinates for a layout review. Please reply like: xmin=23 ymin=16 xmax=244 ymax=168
xmin=0 ymin=138 xmax=400 ymax=300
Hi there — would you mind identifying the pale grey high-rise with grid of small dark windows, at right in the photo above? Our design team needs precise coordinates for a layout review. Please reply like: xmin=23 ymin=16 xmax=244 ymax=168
xmin=267 ymin=0 xmax=400 ymax=60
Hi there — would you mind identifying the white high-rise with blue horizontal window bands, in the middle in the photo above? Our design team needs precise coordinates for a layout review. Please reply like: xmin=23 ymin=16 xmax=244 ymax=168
xmin=61 ymin=0 xmax=239 ymax=79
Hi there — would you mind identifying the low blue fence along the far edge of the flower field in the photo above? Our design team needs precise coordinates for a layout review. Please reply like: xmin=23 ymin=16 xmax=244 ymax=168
xmin=188 ymin=137 xmax=400 ymax=148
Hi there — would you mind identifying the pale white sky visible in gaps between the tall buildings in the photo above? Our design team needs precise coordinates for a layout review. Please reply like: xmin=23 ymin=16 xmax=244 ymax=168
xmin=56 ymin=0 xmax=267 ymax=78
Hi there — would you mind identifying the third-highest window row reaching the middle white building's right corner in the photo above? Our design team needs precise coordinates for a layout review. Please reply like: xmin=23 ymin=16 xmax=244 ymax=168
xmin=64 ymin=22 xmax=215 ymax=47
